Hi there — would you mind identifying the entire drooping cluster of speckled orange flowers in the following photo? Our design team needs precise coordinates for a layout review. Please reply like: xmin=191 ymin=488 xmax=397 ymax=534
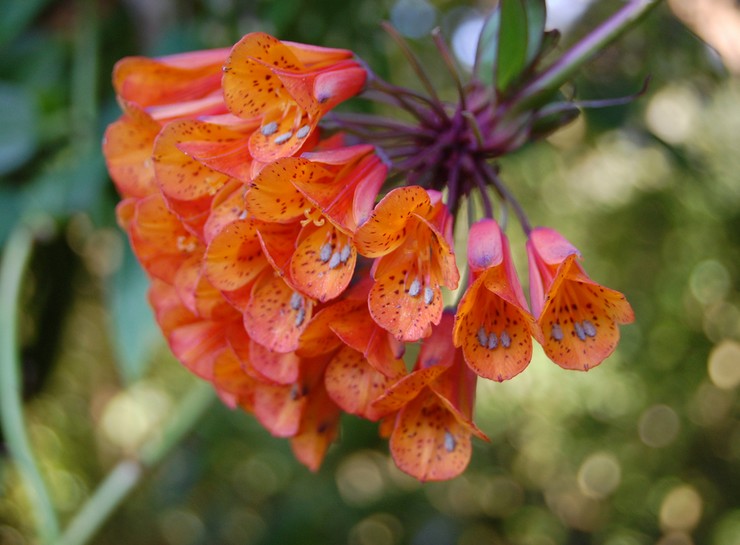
xmin=103 ymin=33 xmax=632 ymax=480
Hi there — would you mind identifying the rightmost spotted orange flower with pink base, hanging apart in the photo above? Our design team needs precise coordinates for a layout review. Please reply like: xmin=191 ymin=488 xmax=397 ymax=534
xmin=527 ymin=227 xmax=635 ymax=371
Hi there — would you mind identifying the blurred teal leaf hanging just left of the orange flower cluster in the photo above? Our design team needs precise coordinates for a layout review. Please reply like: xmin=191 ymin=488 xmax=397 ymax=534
xmin=107 ymin=241 xmax=160 ymax=384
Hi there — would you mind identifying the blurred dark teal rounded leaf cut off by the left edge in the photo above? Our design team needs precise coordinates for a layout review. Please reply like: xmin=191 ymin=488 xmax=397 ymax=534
xmin=0 ymin=84 xmax=37 ymax=175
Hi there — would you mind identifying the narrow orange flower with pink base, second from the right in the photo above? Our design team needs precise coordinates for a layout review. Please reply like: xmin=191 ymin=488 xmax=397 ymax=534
xmin=453 ymin=219 xmax=540 ymax=382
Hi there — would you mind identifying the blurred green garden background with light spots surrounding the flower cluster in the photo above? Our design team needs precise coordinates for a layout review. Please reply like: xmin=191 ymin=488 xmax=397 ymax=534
xmin=0 ymin=0 xmax=740 ymax=545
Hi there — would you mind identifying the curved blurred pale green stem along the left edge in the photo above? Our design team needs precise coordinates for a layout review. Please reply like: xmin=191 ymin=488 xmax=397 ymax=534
xmin=0 ymin=226 xmax=59 ymax=543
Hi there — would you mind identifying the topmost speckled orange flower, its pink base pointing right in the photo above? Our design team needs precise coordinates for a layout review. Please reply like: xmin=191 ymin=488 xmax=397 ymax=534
xmin=223 ymin=32 xmax=366 ymax=162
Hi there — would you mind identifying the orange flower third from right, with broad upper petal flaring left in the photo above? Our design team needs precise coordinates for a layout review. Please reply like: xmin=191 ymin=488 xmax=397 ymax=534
xmin=355 ymin=186 xmax=460 ymax=341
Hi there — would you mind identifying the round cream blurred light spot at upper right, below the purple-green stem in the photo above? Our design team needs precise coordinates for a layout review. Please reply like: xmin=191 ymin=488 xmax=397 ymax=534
xmin=645 ymin=85 xmax=701 ymax=144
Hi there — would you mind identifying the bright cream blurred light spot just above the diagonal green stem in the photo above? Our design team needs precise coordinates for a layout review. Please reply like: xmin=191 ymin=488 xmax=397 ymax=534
xmin=100 ymin=383 xmax=171 ymax=450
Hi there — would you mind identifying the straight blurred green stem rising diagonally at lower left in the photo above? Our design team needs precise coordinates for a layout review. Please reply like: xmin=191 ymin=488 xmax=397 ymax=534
xmin=56 ymin=380 xmax=215 ymax=545
